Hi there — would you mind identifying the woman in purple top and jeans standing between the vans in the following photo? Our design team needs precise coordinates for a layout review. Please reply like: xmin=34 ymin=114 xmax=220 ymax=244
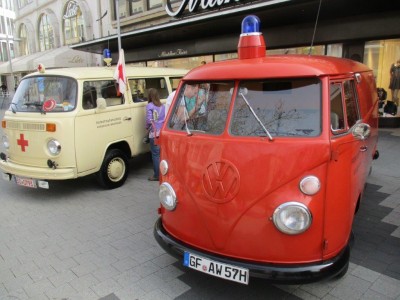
xmin=146 ymin=88 xmax=165 ymax=181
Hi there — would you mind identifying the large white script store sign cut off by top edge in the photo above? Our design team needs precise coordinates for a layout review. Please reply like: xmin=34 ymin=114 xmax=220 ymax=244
xmin=165 ymin=0 xmax=241 ymax=17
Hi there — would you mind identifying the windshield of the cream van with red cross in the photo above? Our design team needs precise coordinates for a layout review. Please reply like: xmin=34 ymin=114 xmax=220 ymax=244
xmin=10 ymin=76 xmax=77 ymax=113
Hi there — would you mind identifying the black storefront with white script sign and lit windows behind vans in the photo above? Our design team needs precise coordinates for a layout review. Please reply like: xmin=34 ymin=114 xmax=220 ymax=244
xmin=72 ymin=0 xmax=400 ymax=101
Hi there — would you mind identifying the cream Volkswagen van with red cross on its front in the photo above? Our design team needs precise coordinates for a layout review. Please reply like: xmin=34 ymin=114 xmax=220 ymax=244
xmin=0 ymin=67 xmax=187 ymax=189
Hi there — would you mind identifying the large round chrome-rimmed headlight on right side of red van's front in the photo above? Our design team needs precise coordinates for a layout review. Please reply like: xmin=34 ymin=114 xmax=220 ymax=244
xmin=273 ymin=202 xmax=312 ymax=234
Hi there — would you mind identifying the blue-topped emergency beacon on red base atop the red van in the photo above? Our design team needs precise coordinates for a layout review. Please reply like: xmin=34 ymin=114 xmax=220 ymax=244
xmin=238 ymin=15 xmax=266 ymax=59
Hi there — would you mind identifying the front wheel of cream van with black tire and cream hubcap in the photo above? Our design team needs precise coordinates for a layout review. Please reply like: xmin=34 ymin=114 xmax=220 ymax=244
xmin=97 ymin=149 xmax=129 ymax=189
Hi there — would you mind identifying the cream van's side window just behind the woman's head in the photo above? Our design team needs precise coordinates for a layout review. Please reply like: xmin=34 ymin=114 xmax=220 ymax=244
xmin=129 ymin=77 xmax=169 ymax=102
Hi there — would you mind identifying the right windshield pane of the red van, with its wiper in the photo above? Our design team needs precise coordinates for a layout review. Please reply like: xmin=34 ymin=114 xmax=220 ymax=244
xmin=230 ymin=78 xmax=321 ymax=137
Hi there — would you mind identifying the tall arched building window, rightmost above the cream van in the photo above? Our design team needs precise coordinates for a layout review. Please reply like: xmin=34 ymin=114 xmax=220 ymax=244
xmin=63 ymin=1 xmax=85 ymax=45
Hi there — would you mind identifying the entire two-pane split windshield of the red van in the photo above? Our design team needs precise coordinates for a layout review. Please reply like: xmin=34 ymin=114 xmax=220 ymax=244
xmin=168 ymin=78 xmax=321 ymax=139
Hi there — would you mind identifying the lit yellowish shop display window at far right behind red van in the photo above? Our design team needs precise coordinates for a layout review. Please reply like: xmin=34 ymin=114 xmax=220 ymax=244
xmin=363 ymin=39 xmax=400 ymax=95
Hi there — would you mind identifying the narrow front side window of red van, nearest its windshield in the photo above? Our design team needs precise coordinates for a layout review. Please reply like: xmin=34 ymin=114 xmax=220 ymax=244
xmin=329 ymin=82 xmax=345 ymax=133
